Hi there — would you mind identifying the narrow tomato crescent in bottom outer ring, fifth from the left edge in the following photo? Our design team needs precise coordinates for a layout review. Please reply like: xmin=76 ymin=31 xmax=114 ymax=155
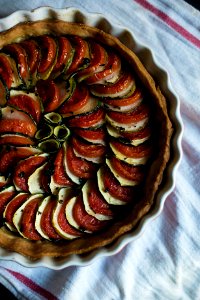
xmin=57 ymin=198 xmax=82 ymax=236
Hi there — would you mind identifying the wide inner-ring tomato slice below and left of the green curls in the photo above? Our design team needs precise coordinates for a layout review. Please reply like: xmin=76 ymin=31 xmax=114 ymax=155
xmin=13 ymin=156 xmax=46 ymax=192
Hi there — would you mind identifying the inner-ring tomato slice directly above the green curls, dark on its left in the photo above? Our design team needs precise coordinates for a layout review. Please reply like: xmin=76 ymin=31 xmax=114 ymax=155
xmin=36 ymin=80 xmax=60 ymax=112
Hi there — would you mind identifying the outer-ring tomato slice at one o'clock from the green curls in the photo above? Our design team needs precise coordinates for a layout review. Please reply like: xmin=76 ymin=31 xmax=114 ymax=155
xmin=77 ymin=41 xmax=107 ymax=81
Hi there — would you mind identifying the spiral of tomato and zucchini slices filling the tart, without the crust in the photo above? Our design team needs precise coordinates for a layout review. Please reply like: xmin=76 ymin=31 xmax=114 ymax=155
xmin=0 ymin=35 xmax=152 ymax=241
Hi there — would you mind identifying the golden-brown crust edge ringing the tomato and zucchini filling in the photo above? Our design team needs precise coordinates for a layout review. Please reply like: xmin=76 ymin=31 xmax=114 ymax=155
xmin=0 ymin=20 xmax=172 ymax=259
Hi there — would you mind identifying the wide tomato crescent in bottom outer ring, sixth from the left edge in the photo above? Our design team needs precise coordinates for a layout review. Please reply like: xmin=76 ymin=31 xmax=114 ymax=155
xmin=73 ymin=195 xmax=108 ymax=232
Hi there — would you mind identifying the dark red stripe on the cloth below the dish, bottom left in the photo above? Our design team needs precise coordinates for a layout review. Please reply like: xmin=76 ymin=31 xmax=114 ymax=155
xmin=4 ymin=268 xmax=58 ymax=300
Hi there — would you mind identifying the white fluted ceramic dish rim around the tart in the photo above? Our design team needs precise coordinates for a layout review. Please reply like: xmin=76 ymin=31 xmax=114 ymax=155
xmin=0 ymin=7 xmax=182 ymax=270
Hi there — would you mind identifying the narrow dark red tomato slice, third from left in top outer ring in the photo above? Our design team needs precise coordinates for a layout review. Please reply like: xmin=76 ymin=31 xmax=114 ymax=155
xmin=21 ymin=40 xmax=40 ymax=74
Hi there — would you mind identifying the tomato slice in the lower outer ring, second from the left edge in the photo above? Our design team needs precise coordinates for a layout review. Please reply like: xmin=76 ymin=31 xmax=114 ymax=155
xmin=4 ymin=193 xmax=30 ymax=226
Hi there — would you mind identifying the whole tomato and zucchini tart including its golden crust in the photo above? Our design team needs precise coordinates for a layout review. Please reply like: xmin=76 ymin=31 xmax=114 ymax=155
xmin=0 ymin=20 xmax=172 ymax=259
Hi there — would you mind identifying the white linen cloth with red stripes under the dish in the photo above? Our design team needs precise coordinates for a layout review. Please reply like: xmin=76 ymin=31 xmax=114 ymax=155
xmin=0 ymin=0 xmax=200 ymax=300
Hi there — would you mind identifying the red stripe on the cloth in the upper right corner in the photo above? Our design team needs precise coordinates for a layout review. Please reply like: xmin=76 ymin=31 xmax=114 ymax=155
xmin=134 ymin=0 xmax=200 ymax=48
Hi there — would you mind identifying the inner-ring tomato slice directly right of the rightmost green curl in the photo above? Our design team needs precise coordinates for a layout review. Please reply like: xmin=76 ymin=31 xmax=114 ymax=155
xmin=74 ymin=127 xmax=106 ymax=142
